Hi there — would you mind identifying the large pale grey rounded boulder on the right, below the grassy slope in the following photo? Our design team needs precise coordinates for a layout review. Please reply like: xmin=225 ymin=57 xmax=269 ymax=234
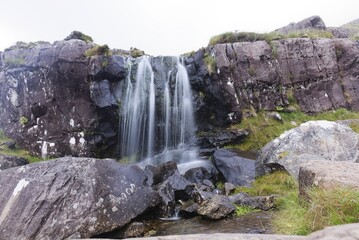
xmin=256 ymin=121 xmax=359 ymax=179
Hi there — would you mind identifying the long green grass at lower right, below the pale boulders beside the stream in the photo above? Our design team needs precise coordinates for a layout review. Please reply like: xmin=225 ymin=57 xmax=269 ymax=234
xmin=236 ymin=171 xmax=359 ymax=235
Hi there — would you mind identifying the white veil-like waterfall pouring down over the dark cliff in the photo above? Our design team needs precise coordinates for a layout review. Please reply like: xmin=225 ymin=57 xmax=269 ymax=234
xmin=119 ymin=56 xmax=197 ymax=164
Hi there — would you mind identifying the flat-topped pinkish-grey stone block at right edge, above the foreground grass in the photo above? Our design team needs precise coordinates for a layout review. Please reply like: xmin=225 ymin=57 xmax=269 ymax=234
xmin=299 ymin=161 xmax=359 ymax=197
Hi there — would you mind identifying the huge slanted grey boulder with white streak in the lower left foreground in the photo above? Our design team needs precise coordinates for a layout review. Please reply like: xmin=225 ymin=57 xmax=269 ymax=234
xmin=0 ymin=157 xmax=159 ymax=239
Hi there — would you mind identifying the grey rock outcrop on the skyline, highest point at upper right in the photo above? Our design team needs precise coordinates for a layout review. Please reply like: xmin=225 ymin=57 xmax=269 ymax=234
xmin=275 ymin=16 xmax=327 ymax=34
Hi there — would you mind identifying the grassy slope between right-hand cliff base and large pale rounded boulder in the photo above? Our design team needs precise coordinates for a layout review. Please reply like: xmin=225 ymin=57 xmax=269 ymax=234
xmin=230 ymin=108 xmax=359 ymax=151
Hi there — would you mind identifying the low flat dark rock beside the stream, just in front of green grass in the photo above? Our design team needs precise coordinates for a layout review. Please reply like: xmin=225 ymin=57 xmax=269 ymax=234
xmin=229 ymin=193 xmax=275 ymax=211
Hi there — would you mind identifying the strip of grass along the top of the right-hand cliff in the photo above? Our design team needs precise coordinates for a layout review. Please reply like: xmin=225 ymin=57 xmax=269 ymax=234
xmin=209 ymin=29 xmax=334 ymax=46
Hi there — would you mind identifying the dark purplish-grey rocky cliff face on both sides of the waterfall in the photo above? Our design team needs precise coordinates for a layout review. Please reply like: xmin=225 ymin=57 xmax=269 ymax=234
xmin=0 ymin=32 xmax=359 ymax=157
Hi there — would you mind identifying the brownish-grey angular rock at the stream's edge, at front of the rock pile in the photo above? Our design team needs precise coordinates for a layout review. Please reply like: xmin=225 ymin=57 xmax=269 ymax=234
xmin=197 ymin=195 xmax=236 ymax=219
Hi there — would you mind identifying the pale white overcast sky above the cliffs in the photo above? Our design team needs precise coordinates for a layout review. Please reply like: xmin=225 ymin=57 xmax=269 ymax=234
xmin=0 ymin=0 xmax=359 ymax=55
